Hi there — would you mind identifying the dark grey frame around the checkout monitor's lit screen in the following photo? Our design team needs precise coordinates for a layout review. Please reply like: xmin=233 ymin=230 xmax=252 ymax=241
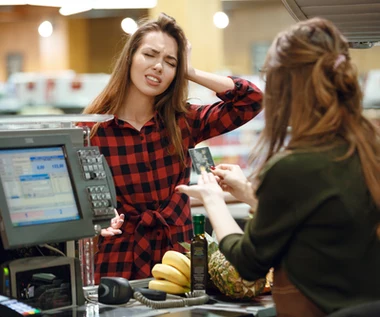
xmin=0 ymin=132 xmax=94 ymax=249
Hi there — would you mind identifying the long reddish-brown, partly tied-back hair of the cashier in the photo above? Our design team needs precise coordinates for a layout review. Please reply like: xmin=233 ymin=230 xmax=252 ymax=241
xmin=253 ymin=18 xmax=380 ymax=207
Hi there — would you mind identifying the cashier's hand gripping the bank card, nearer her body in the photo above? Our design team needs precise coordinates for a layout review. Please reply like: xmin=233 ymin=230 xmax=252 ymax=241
xmin=211 ymin=164 xmax=256 ymax=206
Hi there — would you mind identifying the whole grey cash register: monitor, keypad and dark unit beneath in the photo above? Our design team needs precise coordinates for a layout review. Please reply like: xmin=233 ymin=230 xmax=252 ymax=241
xmin=0 ymin=123 xmax=116 ymax=311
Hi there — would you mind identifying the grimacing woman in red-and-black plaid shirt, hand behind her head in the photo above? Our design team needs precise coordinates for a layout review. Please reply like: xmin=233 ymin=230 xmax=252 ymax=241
xmin=84 ymin=14 xmax=262 ymax=283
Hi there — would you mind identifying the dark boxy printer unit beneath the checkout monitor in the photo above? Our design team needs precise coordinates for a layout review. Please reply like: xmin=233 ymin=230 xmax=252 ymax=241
xmin=0 ymin=256 xmax=84 ymax=311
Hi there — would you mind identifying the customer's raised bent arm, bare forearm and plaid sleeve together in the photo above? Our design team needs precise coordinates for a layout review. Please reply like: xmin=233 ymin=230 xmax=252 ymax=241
xmin=180 ymin=41 xmax=263 ymax=147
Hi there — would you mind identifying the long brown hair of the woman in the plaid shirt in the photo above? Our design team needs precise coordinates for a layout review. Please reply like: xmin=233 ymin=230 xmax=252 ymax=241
xmin=83 ymin=13 xmax=188 ymax=165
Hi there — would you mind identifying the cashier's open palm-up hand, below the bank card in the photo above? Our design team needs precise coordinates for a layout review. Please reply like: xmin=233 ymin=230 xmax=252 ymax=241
xmin=176 ymin=172 xmax=224 ymax=201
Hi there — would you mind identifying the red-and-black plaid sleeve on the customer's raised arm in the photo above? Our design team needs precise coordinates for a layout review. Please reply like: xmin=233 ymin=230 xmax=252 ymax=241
xmin=183 ymin=77 xmax=262 ymax=147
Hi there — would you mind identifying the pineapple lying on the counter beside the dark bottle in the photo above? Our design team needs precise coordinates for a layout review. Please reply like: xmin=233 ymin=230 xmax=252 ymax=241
xmin=181 ymin=233 xmax=266 ymax=300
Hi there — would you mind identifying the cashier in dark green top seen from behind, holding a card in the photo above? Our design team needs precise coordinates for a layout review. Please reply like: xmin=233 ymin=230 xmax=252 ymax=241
xmin=177 ymin=18 xmax=380 ymax=317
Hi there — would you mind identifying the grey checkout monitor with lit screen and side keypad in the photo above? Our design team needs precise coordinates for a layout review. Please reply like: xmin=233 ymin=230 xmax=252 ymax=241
xmin=0 ymin=130 xmax=116 ymax=249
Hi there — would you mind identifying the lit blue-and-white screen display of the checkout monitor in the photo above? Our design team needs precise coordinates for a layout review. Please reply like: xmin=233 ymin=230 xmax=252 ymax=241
xmin=0 ymin=146 xmax=80 ymax=226
